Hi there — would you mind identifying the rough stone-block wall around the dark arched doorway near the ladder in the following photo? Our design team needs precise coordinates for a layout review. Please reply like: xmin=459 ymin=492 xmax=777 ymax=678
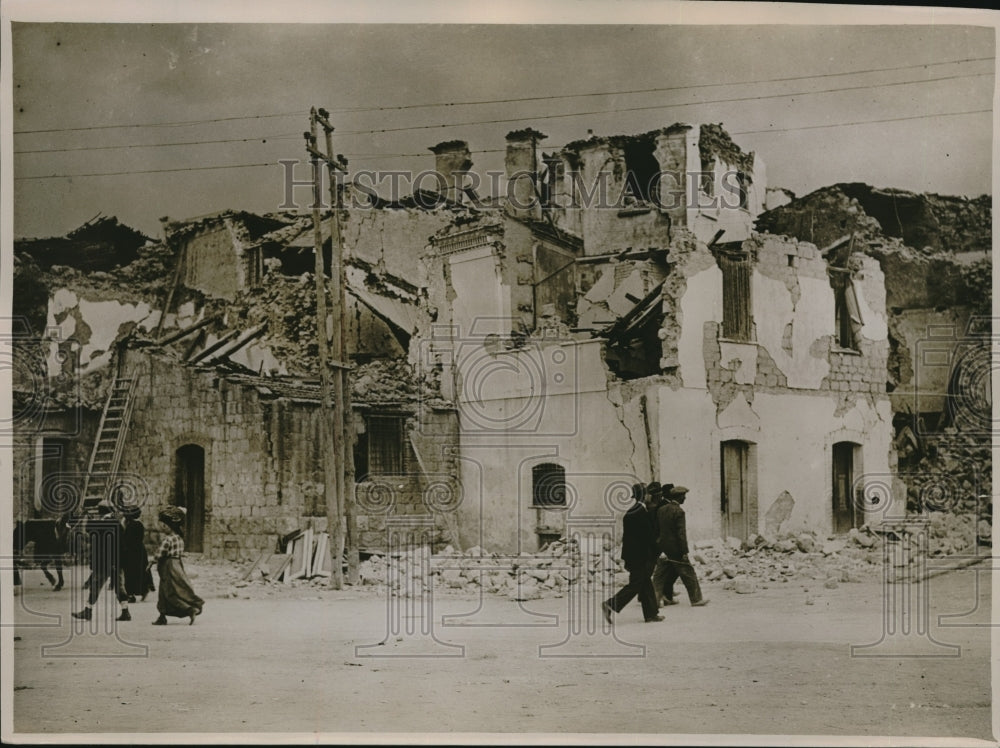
xmin=121 ymin=351 xmax=456 ymax=558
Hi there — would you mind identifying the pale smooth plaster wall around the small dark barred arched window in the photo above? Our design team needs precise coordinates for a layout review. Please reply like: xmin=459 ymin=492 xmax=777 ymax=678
xmin=458 ymin=340 xmax=648 ymax=552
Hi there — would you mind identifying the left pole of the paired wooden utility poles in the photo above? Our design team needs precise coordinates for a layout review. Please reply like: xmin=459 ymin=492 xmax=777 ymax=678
xmin=305 ymin=108 xmax=344 ymax=590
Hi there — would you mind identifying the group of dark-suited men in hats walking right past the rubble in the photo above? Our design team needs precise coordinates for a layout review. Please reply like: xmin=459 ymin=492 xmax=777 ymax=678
xmin=602 ymin=481 xmax=708 ymax=624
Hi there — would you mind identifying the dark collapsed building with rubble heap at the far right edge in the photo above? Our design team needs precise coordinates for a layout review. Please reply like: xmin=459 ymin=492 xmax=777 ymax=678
xmin=757 ymin=183 xmax=993 ymax=520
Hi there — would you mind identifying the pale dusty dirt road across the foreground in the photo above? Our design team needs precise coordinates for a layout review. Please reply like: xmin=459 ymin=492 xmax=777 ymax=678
xmin=5 ymin=567 xmax=991 ymax=739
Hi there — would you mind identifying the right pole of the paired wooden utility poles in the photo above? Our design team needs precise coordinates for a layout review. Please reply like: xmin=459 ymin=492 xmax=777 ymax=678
xmin=318 ymin=109 xmax=360 ymax=584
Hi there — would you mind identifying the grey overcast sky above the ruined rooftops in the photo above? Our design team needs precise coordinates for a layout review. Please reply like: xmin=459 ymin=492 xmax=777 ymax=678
xmin=5 ymin=13 xmax=995 ymax=236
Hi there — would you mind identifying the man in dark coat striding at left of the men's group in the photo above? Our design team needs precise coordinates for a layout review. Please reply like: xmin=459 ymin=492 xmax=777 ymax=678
xmin=601 ymin=483 xmax=663 ymax=624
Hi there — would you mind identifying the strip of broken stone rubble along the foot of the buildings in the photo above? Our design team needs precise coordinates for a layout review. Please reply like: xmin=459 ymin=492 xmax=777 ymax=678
xmin=217 ymin=512 xmax=976 ymax=604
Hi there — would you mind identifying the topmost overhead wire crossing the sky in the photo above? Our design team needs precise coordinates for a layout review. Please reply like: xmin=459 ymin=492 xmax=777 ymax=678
xmin=14 ymin=57 xmax=994 ymax=135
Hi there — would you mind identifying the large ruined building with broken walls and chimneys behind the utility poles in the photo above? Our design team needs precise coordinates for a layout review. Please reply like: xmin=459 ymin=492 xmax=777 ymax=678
xmin=11 ymin=124 xmax=912 ymax=558
